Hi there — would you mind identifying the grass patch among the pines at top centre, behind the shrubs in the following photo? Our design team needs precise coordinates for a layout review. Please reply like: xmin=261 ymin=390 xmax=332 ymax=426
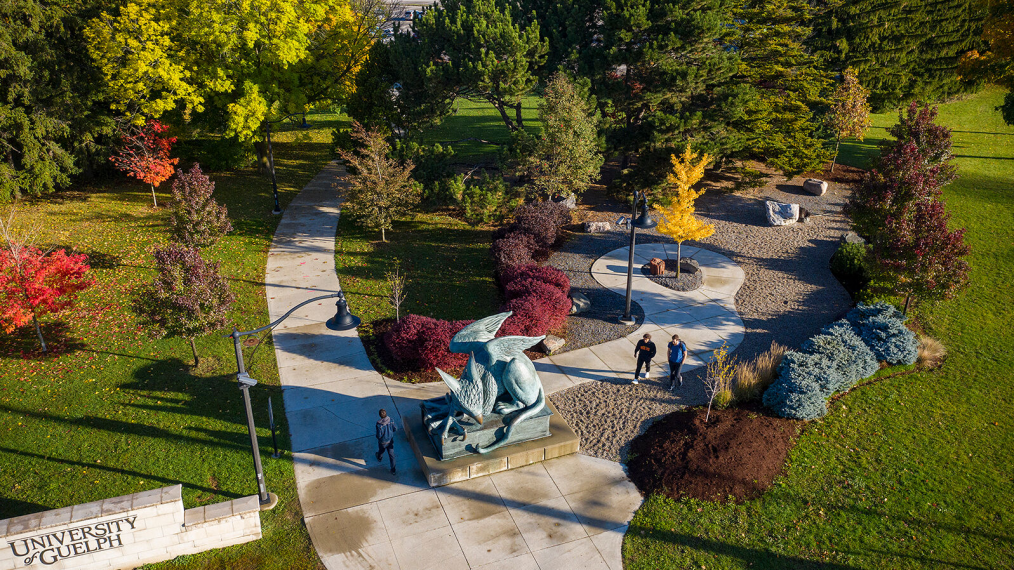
xmin=413 ymin=95 xmax=541 ymax=163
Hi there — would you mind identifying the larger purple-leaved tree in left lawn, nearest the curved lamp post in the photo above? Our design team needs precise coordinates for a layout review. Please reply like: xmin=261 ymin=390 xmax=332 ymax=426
xmin=134 ymin=244 xmax=235 ymax=366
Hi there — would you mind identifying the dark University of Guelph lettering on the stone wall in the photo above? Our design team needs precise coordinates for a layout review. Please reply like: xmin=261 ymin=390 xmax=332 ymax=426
xmin=7 ymin=515 xmax=137 ymax=566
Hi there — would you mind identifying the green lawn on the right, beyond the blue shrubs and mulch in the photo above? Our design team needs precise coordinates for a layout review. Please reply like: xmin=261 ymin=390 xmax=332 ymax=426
xmin=624 ymin=86 xmax=1014 ymax=570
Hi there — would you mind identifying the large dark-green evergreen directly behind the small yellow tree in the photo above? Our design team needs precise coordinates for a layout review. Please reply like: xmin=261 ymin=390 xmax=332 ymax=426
xmin=584 ymin=0 xmax=751 ymax=189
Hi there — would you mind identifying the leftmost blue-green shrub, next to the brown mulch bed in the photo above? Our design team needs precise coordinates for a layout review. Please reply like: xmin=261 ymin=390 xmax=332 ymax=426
xmin=763 ymin=351 xmax=842 ymax=420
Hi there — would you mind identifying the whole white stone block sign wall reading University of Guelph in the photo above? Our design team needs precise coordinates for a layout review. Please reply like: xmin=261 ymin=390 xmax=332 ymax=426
xmin=0 ymin=485 xmax=261 ymax=570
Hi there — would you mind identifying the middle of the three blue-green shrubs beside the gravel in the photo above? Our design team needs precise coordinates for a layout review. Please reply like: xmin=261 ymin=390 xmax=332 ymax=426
xmin=803 ymin=319 xmax=880 ymax=398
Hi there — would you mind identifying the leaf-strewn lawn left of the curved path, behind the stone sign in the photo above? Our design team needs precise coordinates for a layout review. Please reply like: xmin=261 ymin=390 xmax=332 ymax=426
xmin=0 ymin=108 xmax=341 ymax=569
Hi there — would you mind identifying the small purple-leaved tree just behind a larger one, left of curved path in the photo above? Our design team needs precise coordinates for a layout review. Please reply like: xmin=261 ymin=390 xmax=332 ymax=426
xmin=169 ymin=164 xmax=232 ymax=247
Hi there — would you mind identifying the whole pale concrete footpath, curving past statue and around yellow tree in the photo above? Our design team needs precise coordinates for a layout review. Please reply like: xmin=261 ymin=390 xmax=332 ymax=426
xmin=265 ymin=163 xmax=742 ymax=570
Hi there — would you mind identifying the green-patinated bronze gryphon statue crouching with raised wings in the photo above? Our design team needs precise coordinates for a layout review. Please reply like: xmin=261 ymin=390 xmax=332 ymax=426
xmin=427 ymin=311 xmax=546 ymax=453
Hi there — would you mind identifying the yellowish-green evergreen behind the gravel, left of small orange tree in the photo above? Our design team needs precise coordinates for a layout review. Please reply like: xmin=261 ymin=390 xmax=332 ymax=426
xmin=735 ymin=0 xmax=830 ymax=176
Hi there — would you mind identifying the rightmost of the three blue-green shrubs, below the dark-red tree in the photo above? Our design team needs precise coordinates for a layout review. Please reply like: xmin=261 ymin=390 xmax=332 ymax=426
xmin=845 ymin=301 xmax=919 ymax=364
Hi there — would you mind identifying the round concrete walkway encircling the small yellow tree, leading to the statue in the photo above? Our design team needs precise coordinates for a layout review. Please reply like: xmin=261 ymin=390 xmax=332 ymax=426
xmin=535 ymin=243 xmax=745 ymax=393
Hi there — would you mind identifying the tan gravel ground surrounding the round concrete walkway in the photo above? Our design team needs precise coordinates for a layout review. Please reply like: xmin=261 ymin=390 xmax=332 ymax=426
xmin=550 ymin=170 xmax=852 ymax=460
